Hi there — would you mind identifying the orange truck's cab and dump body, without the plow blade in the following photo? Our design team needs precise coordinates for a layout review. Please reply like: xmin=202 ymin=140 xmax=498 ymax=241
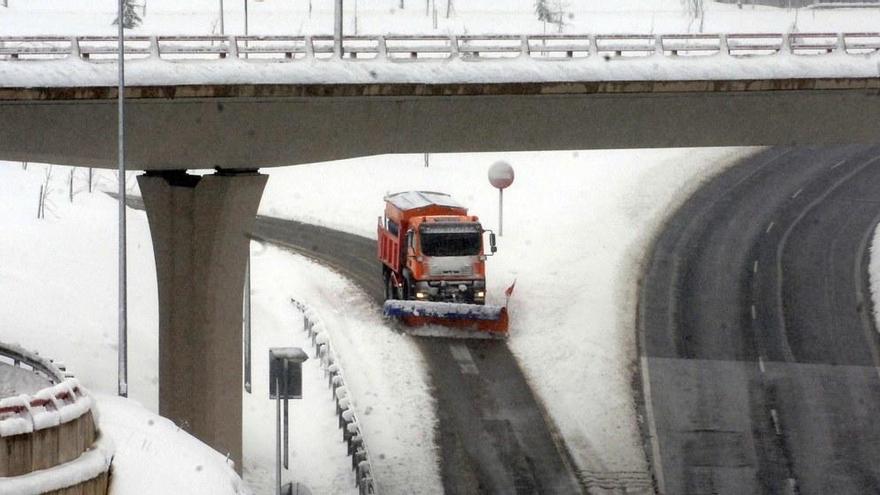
xmin=378 ymin=191 xmax=496 ymax=305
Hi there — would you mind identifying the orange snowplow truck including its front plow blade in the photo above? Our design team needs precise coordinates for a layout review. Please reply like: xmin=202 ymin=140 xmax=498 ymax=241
xmin=377 ymin=191 xmax=508 ymax=334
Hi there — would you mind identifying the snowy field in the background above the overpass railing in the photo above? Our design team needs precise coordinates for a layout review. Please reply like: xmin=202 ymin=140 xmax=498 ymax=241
xmin=0 ymin=0 xmax=880 ymax=35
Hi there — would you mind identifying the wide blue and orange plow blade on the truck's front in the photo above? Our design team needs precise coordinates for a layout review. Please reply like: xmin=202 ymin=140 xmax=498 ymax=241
xmin=383 ymin=300 xmax=508 ymax=335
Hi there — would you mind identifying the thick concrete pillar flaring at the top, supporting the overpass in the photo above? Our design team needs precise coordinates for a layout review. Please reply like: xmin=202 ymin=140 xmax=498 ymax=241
xmin=138 ymin=171 xmax=267 ymax=473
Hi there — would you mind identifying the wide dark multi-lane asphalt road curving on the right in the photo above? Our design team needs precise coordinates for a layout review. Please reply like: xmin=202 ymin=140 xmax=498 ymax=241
xmin=639 ymin=146 xmax=880 ymax=494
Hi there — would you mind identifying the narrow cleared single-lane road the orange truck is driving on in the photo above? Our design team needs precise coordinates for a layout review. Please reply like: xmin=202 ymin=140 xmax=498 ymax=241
xmin=253 ymin=216 xmax=582 ymax=495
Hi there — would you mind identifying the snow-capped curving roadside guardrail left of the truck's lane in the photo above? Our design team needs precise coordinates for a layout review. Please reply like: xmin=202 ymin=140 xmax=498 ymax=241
xmin=290 ymin=298 xmax=379 ymax=495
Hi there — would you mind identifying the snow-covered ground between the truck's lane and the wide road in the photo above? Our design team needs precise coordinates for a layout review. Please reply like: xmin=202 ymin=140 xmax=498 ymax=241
xmin=261 ymin=148 xmax=753 ymax=472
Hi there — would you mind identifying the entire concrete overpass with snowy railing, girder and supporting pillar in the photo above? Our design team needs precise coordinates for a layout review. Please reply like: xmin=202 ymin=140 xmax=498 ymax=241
xmin=0 ymin=33 xmax=880 ymax=472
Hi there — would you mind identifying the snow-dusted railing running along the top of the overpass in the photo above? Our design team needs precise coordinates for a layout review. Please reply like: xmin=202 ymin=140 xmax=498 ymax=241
xmin=0 ymin=32 xmax=880 ymax=62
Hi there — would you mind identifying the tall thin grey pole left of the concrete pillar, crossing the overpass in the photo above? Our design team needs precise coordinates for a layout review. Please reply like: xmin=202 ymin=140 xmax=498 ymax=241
xmin=116 ymin=0 xmax=128 ymax=397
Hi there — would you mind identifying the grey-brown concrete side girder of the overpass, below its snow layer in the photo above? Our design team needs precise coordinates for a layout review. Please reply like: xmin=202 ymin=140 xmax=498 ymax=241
xmin=0 ymin=79 xmax=880 ymax=170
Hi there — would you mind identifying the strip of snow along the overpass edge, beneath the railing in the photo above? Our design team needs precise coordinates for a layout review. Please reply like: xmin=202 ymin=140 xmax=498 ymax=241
xmin=6 ymin=48 xmax=880 ymax=88
